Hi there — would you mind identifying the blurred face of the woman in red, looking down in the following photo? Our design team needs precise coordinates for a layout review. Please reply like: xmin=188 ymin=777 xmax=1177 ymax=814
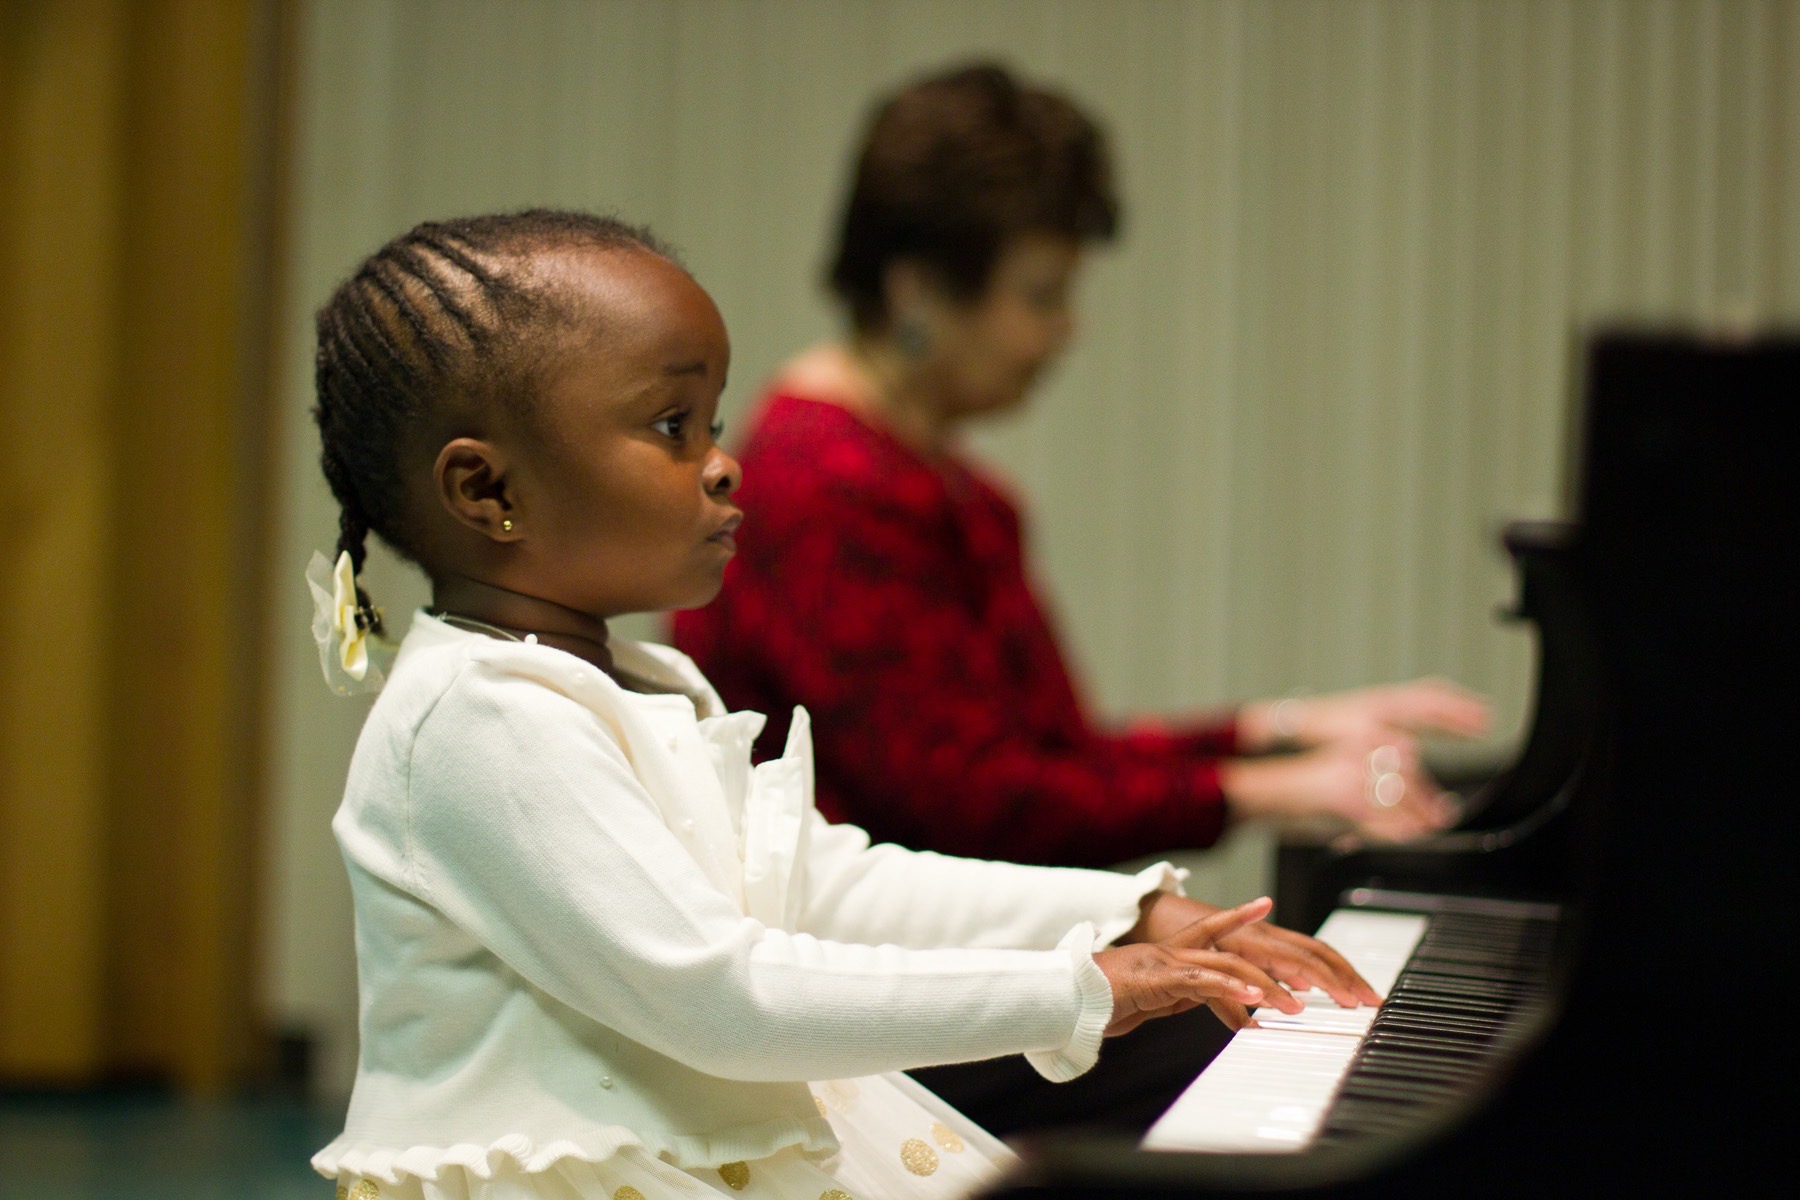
xmin=927 ymin=234 xmax=1082 ymax=417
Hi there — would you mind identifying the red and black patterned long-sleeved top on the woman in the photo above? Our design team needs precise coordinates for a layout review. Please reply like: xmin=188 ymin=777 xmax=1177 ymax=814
xmin=673 ymin=394 xmax=1237 ymax=865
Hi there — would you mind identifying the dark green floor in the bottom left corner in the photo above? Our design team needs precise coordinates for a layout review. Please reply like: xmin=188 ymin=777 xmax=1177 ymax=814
xmin=0 ymin=1092 xmax=342 ymax=1200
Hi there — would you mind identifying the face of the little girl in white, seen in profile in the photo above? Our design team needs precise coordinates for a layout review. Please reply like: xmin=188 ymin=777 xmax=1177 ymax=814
xmin=518 ymin=250 xmax=742 ymax=617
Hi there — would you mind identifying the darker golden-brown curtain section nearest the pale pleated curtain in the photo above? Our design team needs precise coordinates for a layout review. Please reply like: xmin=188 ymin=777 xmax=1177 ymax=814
xmin=110 ymin=0 xmax=268 ymax=1090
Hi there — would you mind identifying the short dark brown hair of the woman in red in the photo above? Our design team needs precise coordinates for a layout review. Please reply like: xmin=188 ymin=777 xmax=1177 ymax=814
xmin=830 ymin=63 xmax=1120 ymax=333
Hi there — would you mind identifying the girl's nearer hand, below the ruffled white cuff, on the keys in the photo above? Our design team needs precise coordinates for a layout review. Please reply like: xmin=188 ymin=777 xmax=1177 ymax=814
xmin=1094 ymin=896 xmax=1303 ymax=1038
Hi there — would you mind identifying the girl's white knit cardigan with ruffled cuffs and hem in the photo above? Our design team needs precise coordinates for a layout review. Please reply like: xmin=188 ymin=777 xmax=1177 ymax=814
xmin=313 ymin=613 xmax=1179 ymax=1182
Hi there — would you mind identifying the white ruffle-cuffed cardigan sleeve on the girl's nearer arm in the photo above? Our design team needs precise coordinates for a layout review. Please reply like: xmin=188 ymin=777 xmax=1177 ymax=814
xmin=372 ymin=662 xmax=1112 ymax=1079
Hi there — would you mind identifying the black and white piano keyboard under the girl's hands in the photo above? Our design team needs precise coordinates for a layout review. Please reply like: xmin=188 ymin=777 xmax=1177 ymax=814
xmin=1143 ymin=896 xmax=1555 ymax=1153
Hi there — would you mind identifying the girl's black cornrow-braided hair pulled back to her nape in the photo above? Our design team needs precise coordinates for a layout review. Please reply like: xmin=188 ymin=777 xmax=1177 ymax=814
xmin=313 ymin=209 xmax=673 ymax=631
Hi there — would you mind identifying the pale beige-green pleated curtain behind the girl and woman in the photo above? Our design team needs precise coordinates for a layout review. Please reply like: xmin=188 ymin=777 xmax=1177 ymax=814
xmin=265 ymin=0 xmax=1800 ymax=1083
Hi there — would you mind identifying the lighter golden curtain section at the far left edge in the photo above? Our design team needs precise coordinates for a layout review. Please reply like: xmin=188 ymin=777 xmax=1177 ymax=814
xmin=0 ymin=0 xmax=126 ymax=1079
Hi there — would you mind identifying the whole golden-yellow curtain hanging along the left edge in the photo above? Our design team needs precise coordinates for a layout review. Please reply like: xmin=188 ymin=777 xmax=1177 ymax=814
xmin=0 ymin=0 xmax=281 ymax=1092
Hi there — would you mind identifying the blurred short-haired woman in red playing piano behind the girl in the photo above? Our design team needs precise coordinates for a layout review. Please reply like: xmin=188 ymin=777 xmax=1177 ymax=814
xmin=673 ymin=65 xmax=1489 ymax=1133
